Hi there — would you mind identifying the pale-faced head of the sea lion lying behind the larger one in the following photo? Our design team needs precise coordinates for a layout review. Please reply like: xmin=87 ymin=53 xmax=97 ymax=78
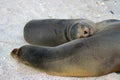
xmin=68 ymin=22 xmax=95 ymax=40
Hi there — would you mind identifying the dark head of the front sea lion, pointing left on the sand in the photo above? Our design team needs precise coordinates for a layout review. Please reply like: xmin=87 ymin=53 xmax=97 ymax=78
xmin=11 ymin=45 xmax=46 ymax=67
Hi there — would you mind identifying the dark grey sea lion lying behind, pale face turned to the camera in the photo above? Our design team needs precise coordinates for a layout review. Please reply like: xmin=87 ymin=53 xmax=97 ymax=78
xmin=24 ymin=19 xmax=95 ymax=46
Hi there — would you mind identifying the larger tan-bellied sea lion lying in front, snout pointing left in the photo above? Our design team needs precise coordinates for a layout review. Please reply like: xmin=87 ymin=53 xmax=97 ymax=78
xmin=11 ymin=23 xmax=120 ymax=77
